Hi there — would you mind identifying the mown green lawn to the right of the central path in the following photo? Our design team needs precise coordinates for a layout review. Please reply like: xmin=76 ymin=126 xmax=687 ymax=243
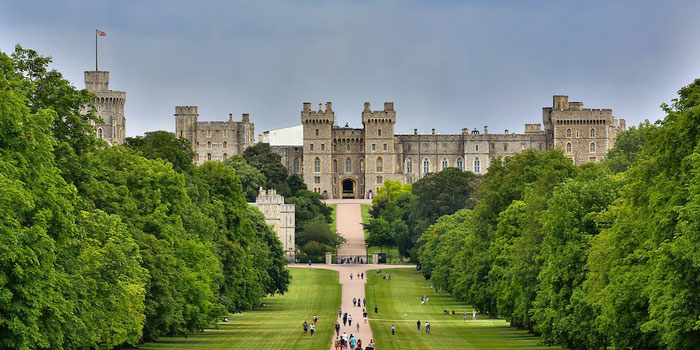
xmin=365 ymin=268 xmax=552 ymax=350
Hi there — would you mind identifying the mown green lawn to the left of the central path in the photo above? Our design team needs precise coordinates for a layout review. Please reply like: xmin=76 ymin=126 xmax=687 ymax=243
xmin=139 ymin=268 xmax=341 ymax=350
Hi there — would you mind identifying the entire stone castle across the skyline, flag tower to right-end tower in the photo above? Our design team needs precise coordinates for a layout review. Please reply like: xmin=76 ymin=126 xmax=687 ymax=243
xmin=85 ymin=71 xmax=625 ymax=198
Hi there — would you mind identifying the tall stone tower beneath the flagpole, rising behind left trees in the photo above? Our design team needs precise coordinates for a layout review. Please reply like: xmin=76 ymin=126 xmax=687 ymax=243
xmin=85 ymin=71 xmax=126 ymax=145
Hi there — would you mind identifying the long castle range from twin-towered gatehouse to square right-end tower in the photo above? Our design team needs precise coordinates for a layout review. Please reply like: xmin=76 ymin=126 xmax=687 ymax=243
xmin=273 ymin=96 xmax=625 ymax=198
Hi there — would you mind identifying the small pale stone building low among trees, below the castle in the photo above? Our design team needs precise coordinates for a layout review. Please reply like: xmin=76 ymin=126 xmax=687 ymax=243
xmin=248 ymin=187 xmax=295 ymax=261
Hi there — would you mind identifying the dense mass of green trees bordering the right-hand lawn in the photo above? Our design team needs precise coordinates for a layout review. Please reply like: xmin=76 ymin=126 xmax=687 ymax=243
xmin=375 ymin=79 xmax=700 ymax=349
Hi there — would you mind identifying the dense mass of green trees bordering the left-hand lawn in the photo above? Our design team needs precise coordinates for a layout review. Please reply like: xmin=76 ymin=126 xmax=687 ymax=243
xmin=0 ymin=45 xmax=290 ymax=349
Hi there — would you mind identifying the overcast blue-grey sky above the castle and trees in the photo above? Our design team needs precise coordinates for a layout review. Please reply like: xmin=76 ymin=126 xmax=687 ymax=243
xmin=0 ymin=0 xmax=700 ymax=136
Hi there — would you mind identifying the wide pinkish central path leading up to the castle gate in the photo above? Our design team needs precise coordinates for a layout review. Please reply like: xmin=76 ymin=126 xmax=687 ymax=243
xmin=312 ymin=199 xmax=407 ymax=350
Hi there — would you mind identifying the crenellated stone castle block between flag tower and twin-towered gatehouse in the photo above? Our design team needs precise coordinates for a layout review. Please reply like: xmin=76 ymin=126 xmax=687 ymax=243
xmin=175 ymin=106 xmax=255 ymax=165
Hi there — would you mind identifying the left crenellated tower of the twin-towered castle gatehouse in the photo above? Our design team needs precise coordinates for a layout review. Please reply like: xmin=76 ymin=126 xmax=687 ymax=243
xmin=301 ymin=102 xmax=335 ymax=198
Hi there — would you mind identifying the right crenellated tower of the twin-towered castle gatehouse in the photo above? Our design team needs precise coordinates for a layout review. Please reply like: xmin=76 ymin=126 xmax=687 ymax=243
xmin=362 ymin=102 xmax=397 ymax=198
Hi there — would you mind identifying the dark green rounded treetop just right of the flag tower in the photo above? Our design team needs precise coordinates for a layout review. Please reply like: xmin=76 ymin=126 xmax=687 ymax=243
xmin=124 ymin=130 xmax=194 ymax=173
